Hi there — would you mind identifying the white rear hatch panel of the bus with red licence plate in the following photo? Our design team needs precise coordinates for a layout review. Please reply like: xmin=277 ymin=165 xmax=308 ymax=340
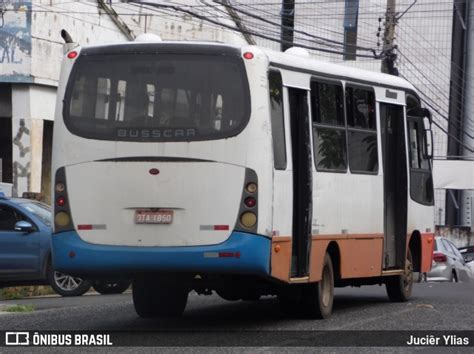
xmin=66 ymin=160 xmax=245 ymax=247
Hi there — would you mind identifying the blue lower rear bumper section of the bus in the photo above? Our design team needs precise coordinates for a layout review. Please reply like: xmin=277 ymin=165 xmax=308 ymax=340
xmin=52 ymin=231 xmax=271 ymax=275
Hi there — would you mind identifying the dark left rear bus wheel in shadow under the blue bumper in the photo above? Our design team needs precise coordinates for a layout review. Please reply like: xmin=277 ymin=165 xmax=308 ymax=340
xmin=132 ymin=277 xmax=189 ymax=318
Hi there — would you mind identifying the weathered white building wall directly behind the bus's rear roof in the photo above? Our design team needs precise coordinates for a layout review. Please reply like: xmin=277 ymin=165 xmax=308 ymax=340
xmin=31 ymin=0 xmax=245 ymax=86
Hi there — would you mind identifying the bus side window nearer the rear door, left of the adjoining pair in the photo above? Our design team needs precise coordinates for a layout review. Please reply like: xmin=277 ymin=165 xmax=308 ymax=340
xmin=311 ymin=81 xmax=347 ymax=172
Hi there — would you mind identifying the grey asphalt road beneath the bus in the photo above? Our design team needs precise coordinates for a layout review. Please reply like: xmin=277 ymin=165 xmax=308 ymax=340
xmin=0 ymin=283 xmax=474 ymax=331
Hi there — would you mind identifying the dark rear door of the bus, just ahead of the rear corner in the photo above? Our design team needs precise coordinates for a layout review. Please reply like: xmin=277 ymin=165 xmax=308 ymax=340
xmin=288 ymin=87 xmax=313 ymax=277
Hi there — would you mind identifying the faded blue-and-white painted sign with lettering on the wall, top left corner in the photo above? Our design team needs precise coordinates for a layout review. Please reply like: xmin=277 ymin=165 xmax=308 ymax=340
xmin=0 ymin=0 xmax=31 ymax=82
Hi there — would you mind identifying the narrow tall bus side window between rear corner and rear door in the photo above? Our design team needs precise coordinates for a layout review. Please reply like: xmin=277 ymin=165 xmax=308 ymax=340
xmin=268 ymin=70 xmax=286 ymax=170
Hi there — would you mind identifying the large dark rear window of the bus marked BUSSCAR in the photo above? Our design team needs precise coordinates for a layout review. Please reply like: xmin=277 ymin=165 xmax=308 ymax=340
xmin=63 ymin=54 xmax=254 ymax=142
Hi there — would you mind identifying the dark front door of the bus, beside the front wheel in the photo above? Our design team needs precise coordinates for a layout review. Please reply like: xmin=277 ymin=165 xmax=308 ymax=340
xmin=379 ymin=103 xmax=408 ymax=269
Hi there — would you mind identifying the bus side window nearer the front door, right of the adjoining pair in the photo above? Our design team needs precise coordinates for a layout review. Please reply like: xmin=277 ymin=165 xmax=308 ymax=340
xmin=346 ymin=87 xmax=379 ymax=174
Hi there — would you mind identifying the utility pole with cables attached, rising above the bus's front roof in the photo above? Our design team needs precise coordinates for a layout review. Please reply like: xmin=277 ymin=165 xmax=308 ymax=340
xmin=382 ymin=0 xmax=398 ymax=76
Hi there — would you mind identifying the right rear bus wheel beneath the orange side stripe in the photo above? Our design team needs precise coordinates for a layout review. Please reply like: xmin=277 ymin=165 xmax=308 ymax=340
xmin=302 ymin=253 xmax=334 ymax=319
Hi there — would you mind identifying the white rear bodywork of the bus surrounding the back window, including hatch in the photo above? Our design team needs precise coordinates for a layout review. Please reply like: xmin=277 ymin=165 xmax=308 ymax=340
xmin=53 ymin=43 xmax=272 ymax=252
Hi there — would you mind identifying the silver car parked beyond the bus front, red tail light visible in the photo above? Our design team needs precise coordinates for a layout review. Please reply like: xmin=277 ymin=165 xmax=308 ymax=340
xmin=426 ymin=237 xmax=471 ymax=282
